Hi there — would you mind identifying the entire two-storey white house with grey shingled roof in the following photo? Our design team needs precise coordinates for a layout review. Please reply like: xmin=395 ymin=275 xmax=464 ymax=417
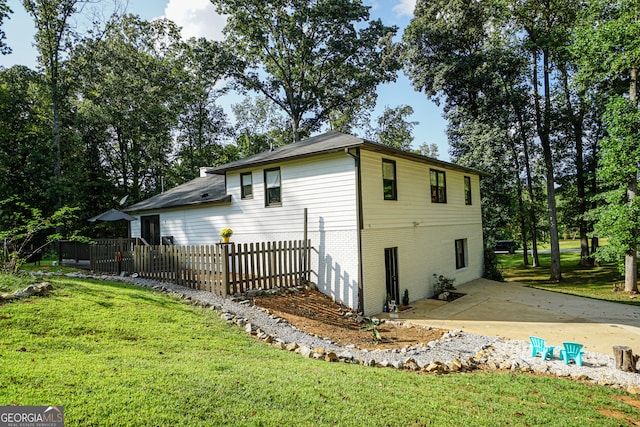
xmin=127 ymin=132 xmax=483 ymax=314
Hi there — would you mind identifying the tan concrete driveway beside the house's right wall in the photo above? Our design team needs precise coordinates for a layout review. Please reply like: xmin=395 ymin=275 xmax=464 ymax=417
xmin=379 ymin=279 xmax=640 ymax=355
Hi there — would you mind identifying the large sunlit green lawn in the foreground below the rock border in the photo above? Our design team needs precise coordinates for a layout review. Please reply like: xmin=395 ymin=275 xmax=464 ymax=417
xmin=0 ymin=278 xmax=640 ymax=426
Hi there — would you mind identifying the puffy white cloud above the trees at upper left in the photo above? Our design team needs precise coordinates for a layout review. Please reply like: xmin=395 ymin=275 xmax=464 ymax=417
xmin=164 ymin=0 xmax=227 ymax=40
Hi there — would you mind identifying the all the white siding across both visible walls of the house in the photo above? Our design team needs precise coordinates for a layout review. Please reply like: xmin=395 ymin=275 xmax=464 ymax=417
xmin=132 ymin=145 xmax=483 ymax=314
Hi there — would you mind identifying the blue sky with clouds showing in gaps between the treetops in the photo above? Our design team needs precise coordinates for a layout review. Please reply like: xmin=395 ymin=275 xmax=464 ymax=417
xmin=0 ymin=0 xmax=449 ymax=160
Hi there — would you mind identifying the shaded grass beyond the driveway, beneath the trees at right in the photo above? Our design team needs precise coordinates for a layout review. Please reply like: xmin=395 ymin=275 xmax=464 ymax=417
xmin=498 ymin=246 xmax=640 ymax=305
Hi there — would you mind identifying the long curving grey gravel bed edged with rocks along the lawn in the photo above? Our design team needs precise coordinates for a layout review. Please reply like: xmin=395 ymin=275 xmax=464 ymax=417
xmin=33 ymin=273 xmax=640 ymax=394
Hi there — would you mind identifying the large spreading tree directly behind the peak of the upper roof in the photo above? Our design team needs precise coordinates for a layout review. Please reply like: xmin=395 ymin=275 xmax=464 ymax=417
xmin=211 ymin=0 xmax=400 ymax=141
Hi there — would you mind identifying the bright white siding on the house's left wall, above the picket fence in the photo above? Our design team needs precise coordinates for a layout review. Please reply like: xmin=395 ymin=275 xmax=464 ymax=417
xmin=131 ymin=153 xmax=358 ymax=308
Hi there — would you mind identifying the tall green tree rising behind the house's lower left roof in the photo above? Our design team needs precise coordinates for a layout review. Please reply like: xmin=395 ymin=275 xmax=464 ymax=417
xmin=73 ymin=15 xmax=187 ymax=201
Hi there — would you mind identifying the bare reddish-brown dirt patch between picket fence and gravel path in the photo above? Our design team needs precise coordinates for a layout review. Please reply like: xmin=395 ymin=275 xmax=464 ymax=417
xmin=254 ymin=290 xmax=447 ymax=349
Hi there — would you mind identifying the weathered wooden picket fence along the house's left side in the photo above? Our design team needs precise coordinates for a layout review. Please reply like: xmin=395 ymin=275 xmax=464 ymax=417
xmin=92 ymin=240 xmax=311 ymax=296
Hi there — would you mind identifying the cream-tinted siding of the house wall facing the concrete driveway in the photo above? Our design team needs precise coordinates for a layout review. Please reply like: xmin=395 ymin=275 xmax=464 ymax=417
xmin=361 ymin=152 xmax=483 ymax=314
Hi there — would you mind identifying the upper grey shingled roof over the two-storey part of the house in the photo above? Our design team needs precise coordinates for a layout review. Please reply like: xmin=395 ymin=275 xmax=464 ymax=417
xmin=205 ymin=131 xmax=487 ymax=176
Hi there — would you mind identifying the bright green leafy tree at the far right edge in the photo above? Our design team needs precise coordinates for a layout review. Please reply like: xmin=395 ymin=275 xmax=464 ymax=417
xmin=576 ymin=0 xmax=640 ymax=292
